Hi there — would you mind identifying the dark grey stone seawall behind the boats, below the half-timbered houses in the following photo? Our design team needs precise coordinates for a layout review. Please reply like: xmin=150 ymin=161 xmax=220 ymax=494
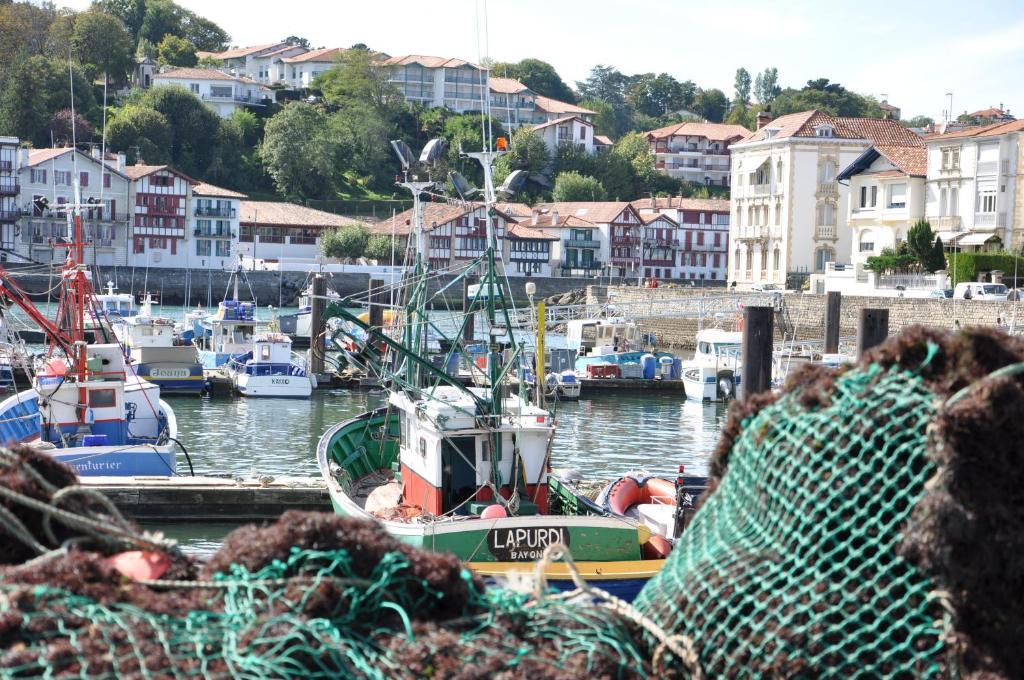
xmin=9 ymin=266 xmax=586 ymax=308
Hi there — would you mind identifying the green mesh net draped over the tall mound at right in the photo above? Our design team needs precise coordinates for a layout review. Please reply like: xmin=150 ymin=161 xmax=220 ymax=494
xmin=636 ymin=366 xmax=946 ymax=678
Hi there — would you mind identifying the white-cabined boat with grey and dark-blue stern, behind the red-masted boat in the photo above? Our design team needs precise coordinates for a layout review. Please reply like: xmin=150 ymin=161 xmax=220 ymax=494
xmin=112 ymin=296 xmax=206 ymax=394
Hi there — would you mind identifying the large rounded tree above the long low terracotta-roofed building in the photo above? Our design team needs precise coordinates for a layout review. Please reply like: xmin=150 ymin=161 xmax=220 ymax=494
xmin=260 ymin=101 xmax=338 ymax=199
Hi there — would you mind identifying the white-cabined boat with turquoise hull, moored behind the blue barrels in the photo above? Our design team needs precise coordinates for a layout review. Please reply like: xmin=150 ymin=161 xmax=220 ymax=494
xmin=565 ymin=317 xmax=675 ymax=373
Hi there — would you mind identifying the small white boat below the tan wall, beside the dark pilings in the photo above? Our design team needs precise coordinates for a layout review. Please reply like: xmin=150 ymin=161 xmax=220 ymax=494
xmin=682 ymin=328 xmax=743 ymax=401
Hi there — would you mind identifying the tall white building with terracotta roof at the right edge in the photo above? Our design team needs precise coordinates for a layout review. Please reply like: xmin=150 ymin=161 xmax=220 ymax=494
xmin=925 ymin=121 xmax=1024 ymax=251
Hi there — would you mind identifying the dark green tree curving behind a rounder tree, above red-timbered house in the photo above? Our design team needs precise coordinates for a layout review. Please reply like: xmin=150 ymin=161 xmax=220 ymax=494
xmin=140 ymin=86 xmax=220 ymax=177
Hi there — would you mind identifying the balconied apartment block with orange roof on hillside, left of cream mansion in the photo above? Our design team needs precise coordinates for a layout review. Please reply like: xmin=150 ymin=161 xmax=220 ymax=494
xmin=646 ymin=122 xmax=751 ymax=186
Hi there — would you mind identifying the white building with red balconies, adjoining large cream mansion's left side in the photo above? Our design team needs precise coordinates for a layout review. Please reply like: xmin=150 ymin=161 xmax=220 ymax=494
xmin=633 ymin=197 xmax=730 ymax=282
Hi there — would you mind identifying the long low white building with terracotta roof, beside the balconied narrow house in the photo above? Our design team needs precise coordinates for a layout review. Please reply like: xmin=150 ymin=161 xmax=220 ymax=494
xmin=238 ymin=200 xmax=359 ymax=262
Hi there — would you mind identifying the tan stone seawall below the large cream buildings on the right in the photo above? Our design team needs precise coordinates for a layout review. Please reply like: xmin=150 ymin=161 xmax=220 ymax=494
xmin=588 ymin=286 xmax=1024 ymax=349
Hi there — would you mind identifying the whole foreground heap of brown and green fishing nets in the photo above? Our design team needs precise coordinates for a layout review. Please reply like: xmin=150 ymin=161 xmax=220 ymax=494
xmin=0 ymin=329 xmax=1024 ymax=679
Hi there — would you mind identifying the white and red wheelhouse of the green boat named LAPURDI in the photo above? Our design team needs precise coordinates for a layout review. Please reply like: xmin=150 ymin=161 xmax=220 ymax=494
xmin=390 ymin=386 xmax=554 ymax=515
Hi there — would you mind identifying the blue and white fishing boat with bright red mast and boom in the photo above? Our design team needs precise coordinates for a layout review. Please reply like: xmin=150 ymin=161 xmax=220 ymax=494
xmin=0 ymin=183 xmax=179 ymax=476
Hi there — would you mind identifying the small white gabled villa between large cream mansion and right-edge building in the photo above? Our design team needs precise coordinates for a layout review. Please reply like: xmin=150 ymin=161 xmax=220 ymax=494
xmin=836 ymin=144 xmax=928 ymax=271
